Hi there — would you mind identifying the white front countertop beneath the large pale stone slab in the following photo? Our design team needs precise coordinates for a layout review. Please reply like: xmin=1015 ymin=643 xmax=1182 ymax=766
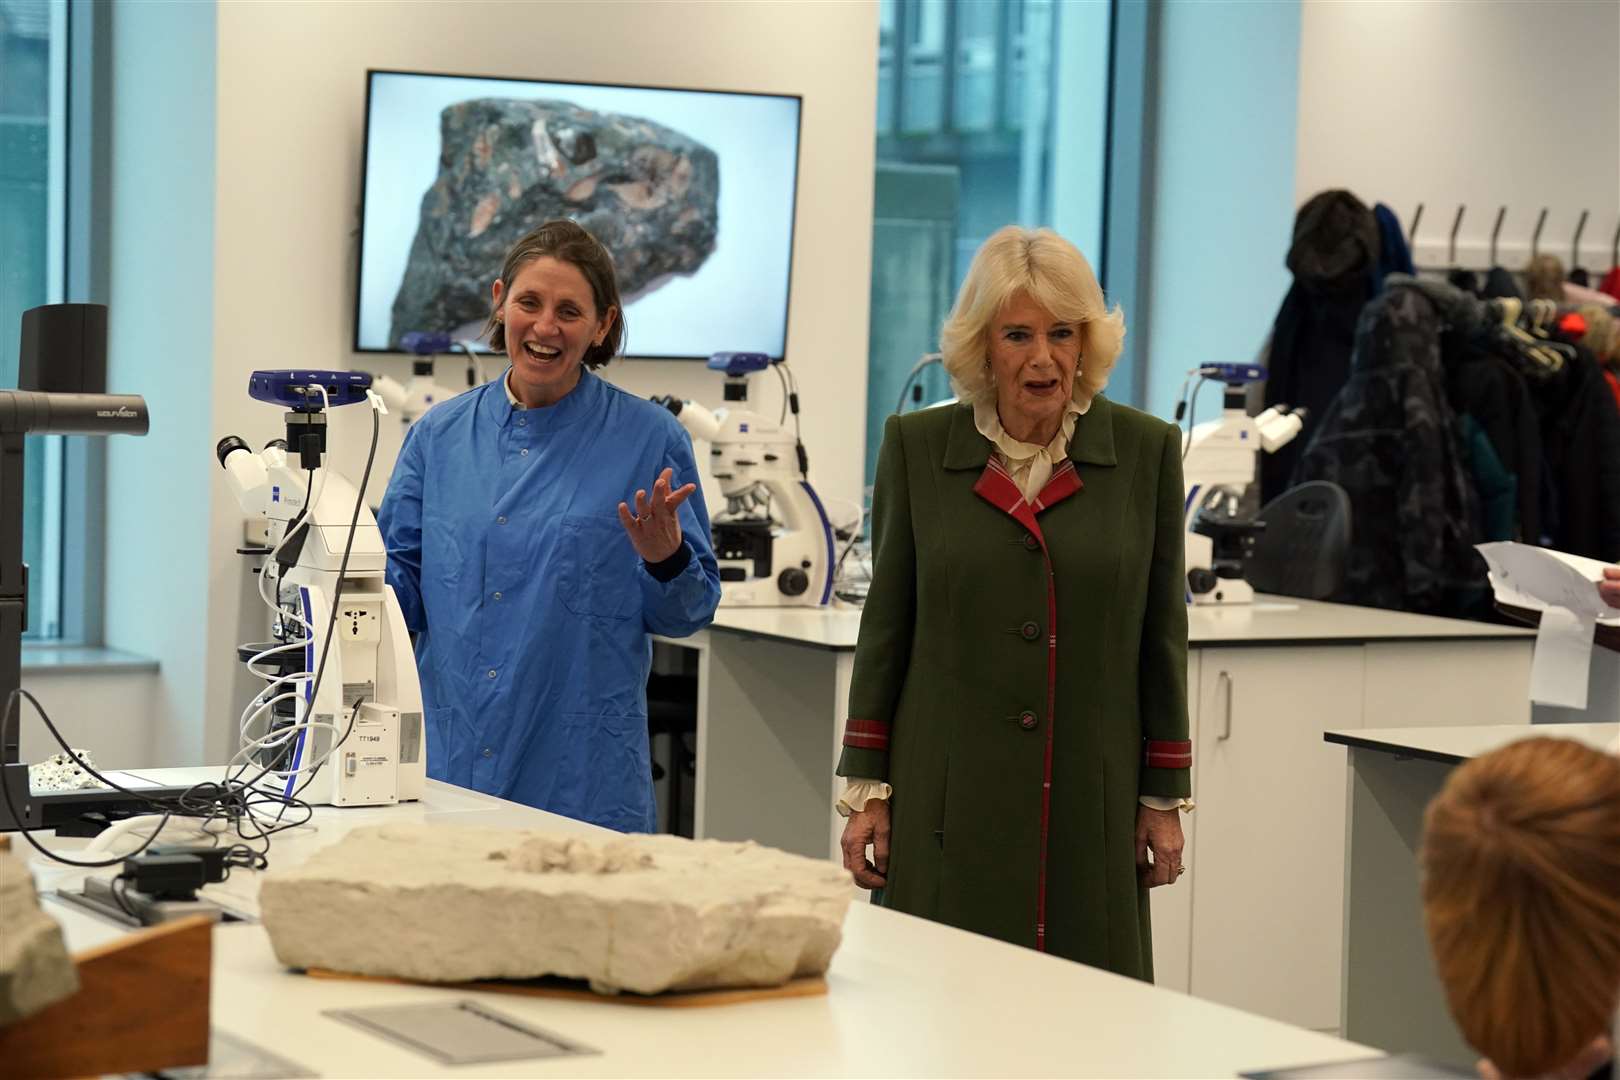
xmin=34 ymin=769 xmax=1377 ymax=1077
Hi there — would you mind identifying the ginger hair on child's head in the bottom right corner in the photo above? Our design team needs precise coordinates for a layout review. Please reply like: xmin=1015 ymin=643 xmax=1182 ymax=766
xmin=1419 ymin=738 xmax=1620 ymax=1077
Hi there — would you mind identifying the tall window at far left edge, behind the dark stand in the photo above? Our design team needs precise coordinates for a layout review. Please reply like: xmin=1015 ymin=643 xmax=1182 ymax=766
xmin=0 ymin=0 xmax=68 ymax=640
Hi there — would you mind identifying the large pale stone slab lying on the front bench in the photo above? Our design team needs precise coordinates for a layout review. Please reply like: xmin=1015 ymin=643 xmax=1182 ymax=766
xmin=259 ymin=826 xmax=852 ymax=994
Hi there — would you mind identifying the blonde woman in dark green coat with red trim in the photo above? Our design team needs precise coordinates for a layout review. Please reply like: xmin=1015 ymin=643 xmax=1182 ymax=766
xmin=838 ymin=225 xmax=1192 ymax=980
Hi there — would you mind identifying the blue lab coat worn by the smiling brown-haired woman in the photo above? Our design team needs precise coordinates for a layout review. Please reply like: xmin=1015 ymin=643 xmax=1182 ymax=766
xmin=377 ymin=371 xmax=719 ymax=832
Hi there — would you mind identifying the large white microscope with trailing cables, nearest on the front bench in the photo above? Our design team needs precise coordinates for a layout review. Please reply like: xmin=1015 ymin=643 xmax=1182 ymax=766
xmin=215 ymin=369 xmax=428 ymax=806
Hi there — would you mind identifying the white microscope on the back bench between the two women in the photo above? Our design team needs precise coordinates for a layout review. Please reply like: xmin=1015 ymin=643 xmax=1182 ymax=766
xmin=653 ymin=353 xmax=838 ymax=607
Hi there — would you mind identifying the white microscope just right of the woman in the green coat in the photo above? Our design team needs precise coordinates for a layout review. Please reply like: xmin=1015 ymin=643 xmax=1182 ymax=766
xmin=1176 ymin=364 xmax=1304 ymax=604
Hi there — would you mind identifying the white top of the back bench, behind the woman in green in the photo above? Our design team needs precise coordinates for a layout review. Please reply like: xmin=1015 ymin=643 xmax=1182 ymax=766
xmin=706 ymin=596 xmax=1536 ymax=651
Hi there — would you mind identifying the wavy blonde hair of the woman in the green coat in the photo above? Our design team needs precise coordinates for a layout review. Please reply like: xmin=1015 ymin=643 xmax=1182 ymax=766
xmin=940 ymin=225 xmax=1124 ymax=406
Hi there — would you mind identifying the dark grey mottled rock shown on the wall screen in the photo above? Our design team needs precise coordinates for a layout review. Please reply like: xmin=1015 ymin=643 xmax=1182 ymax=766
xmin=389 ymin=97 xmax=719 ymax=343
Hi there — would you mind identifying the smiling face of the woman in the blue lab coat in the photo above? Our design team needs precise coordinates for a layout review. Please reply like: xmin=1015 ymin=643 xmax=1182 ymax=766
xmin=494 ymin=256 xmax=619 ymax=408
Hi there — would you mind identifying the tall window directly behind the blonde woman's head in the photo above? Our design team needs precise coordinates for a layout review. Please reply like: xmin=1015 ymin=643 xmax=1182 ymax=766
xmin=867 ymin=0 xmax=1111 ymax=484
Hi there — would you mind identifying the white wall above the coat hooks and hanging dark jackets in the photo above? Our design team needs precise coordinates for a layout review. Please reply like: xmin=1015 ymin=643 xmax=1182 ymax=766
xmin=1294 ymin=0 xmax=1620 ymax=269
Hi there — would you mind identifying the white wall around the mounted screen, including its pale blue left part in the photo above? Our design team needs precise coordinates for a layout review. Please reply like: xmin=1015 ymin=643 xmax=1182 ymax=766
xmin=68 ymin=0 xmax=876 ymax=764
